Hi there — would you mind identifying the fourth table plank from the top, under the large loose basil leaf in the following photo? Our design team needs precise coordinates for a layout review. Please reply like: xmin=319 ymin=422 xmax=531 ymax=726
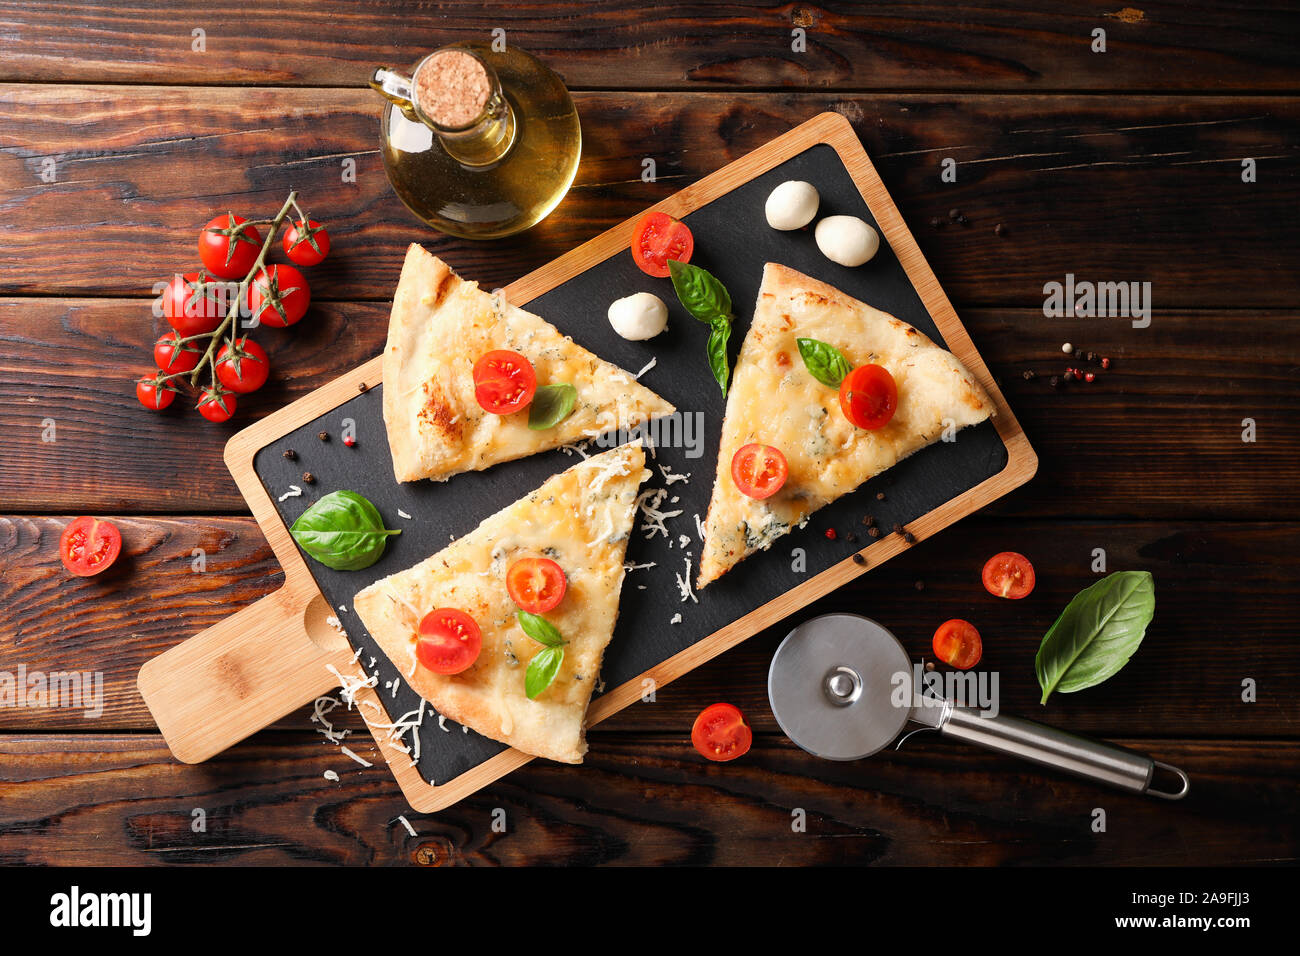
xmin=0 ymin=516 xmax=1300 ymax=740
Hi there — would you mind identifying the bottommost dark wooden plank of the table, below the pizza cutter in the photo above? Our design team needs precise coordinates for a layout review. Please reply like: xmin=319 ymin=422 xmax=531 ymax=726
xmin=0 ymin=731 xmax=1300 ymax=866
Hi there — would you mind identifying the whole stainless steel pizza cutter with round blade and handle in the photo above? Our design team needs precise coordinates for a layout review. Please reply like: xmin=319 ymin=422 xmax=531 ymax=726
xmin=767 ymin=614 xmax=1191 ymax=800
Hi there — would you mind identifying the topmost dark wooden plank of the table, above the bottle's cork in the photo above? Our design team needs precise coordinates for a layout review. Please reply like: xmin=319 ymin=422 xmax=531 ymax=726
xmin=0 ymin=0 xmax=1300 ymax=90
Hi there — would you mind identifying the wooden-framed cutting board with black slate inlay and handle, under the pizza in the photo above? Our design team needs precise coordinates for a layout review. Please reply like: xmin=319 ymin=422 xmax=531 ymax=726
xmin=139 ymin=113 xmax=1037 ymax=812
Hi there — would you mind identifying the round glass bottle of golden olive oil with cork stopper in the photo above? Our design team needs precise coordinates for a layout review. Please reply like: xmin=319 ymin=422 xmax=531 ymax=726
xmin=371 ymin=43 xmax=582 ymax=239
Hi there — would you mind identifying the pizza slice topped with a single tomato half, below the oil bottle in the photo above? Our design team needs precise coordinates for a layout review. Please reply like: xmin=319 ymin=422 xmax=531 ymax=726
xmin=384 ymin=243 xmax=673 ymax=481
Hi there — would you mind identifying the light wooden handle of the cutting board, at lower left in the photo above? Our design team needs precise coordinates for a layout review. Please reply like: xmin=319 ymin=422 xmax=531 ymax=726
xmin=137 ymin=587 xmax=356 ymax=763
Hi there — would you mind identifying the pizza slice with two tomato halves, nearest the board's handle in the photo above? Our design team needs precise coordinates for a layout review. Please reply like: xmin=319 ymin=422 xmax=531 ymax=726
xmin=352 ymin=442 xmax=650 ymax=763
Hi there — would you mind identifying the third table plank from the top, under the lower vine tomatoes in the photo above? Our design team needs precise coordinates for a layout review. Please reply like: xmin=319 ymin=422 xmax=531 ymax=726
xmin=0 ymin=303 xmax=1300 ymax=520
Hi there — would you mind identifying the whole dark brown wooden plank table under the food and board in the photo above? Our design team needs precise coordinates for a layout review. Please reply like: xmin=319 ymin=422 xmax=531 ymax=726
xmin=0 ymin=0 xmax=1300 ymax=864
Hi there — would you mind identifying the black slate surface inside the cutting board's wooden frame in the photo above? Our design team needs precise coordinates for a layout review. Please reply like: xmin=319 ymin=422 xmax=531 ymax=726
xmin=254 ymin=144 xmax=1008 ymax=784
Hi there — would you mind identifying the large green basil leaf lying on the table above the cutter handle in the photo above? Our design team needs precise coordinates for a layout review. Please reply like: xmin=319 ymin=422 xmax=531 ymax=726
xmin=1034 ymin=571 xmax=1156 ymax=704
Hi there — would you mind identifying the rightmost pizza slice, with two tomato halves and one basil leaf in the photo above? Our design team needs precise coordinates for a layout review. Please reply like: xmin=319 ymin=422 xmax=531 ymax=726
xmin=697 ymin=263 xmax=993 ymax=588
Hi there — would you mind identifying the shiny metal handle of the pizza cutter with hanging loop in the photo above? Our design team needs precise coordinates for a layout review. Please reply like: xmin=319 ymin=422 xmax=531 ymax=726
xmin=941 ymin=708 xmax=1191 ymax=800
